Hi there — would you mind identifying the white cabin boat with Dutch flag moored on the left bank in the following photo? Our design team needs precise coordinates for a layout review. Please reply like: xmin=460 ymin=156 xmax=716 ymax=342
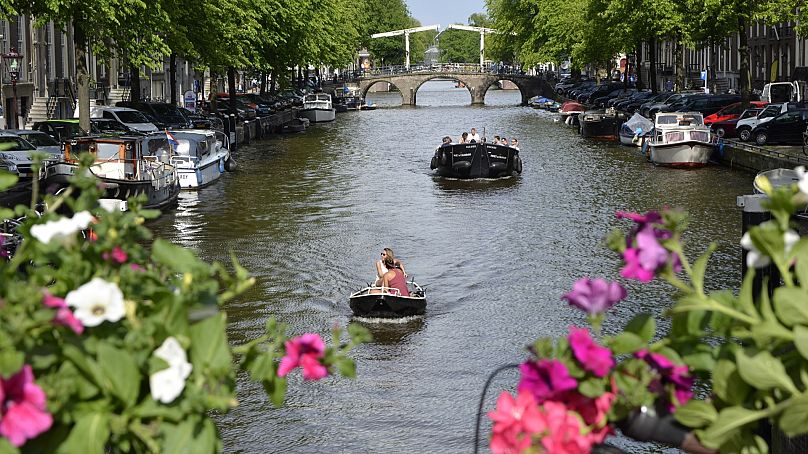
xmin=161 ymin=129 xmax=233 ymax=189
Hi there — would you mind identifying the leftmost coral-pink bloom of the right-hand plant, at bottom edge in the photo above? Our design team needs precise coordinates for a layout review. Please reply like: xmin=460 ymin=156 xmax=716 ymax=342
xmin=488 ymin=391 xmax=547 ymax=454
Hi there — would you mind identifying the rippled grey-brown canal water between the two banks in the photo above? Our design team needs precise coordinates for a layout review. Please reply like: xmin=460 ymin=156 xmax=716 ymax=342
xmin=153 ymin=82 xmax=752 ymax=453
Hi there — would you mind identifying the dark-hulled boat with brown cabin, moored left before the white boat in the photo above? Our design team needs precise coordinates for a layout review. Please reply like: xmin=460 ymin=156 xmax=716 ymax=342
xmin=46 ymin=133 xmax=180 ymax=210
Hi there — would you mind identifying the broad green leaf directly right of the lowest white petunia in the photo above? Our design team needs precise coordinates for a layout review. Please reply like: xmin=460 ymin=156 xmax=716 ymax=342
xmin=190 ymin=313 xmax=232 ymax=375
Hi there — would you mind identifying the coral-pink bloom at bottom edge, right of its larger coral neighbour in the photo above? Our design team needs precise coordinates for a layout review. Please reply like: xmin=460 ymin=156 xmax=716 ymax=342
xmin=541 ymin=401 xmax=592 ymax=454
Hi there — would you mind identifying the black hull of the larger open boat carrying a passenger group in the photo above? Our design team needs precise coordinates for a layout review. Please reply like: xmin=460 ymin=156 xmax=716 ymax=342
xmin=430 ymin=143 xmax=522 ymax=178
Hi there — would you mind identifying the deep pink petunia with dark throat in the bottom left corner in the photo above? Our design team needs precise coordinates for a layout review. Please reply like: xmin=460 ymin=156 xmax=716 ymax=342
xmin=0 ymin=364 xmax=53 ymax=447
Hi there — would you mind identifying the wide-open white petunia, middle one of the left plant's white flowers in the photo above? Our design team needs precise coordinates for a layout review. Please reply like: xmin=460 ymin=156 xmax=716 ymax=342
xmin=65 ymin=277 xmax=126 ymax=326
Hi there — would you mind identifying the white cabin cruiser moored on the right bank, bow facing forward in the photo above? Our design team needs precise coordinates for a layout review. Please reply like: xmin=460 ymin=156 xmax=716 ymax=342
xmin=648 ymin=112 xmax=714 ymax=167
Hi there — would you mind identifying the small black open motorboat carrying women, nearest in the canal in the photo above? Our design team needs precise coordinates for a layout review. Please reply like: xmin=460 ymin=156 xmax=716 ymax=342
xmin=348 ymin=280 xmax=426 ymax=318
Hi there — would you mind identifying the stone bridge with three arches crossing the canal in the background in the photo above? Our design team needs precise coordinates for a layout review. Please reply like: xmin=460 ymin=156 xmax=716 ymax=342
xmin=359 ymin=72 xmax=555 ymax=106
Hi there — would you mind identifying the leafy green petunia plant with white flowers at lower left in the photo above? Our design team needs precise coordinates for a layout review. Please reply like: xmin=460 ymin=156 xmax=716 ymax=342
xmin=0 ymin=156 xmax=368 ymax=453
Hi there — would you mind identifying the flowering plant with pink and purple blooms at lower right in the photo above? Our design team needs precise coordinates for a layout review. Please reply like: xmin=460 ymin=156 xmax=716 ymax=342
xmin=489 ymin=168 xmax=808 ymax=453
